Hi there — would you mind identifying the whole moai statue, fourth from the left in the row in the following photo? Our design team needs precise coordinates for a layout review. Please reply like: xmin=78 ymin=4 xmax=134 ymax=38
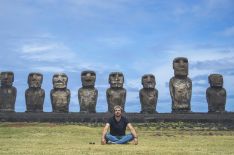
xmin=78 ymin=71 xmax=98 ymax=113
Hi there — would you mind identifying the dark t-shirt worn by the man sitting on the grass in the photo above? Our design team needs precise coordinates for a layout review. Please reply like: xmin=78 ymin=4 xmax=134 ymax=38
xmin=108 ymin=116 xmax=129 ymax=136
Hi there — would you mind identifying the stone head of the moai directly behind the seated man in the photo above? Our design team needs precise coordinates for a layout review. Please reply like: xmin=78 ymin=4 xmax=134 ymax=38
xmin=109 ymin=72 xmax=124 ymax=88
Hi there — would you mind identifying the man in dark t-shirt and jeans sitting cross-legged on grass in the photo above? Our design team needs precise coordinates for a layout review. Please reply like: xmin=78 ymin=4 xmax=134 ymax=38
xmin=101 ymin=106 xmax=138 ymax=145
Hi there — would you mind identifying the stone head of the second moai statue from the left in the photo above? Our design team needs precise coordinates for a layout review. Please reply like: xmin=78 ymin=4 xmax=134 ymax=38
xmin=28 ymin=73 xmax=43 ymax=88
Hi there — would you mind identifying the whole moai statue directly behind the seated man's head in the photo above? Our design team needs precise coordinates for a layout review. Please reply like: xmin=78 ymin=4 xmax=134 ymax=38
xmin=106 ymin=72 xmax=126 ymax=113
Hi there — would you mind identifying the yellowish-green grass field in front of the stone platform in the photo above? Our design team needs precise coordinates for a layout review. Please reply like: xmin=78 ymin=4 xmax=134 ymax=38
xmin=0 ymin=122 xmax=234 ymax=155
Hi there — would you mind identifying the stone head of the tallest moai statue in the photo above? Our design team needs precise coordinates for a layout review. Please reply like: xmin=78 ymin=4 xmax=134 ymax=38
xmin=173 ymin=57 xmax=188 ymax=76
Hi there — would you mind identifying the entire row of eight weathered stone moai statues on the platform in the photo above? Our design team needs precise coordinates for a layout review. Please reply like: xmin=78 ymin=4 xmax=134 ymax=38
xmin=0 ymin=57 xmax=226 ymax=113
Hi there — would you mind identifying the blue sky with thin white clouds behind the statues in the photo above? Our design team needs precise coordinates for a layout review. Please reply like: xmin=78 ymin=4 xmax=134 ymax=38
xmin=0 ymin=0 xmax=234 ymax=112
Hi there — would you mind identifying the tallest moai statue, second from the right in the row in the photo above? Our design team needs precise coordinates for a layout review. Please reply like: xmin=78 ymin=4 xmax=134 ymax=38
xmin=169 ymin=57 xmax=192 ymax=112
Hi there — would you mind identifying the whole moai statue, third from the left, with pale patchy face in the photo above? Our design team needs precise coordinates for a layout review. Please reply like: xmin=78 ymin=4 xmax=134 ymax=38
xmin=50 ymin=73 xmax=71 ymax=112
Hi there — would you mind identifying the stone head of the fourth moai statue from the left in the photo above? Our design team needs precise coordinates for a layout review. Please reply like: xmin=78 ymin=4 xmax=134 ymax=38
xmin=81 ymin=71 xmax=96 ymax=87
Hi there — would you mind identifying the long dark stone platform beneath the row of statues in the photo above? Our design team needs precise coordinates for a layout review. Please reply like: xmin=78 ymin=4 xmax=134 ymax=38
xmin=0 ymin=112 xmax=234 ymax=123
